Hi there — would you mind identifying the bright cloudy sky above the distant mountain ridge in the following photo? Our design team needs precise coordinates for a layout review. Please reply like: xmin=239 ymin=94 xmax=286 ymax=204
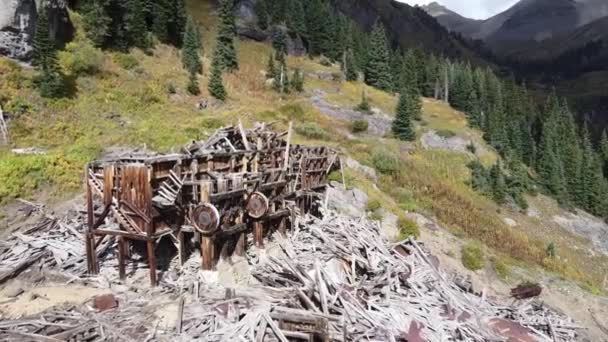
xmin=398 ymin=0 xmax=517 ymax=19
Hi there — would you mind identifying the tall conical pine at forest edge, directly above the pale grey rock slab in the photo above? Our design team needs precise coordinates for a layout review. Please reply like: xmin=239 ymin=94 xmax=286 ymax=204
xmin=365 ymin=21 xmax=392 ymax=91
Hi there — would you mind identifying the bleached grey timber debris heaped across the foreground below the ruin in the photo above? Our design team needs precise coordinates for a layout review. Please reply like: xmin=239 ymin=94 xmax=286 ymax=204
xmin=0 ymin=208 xmax=580 ymax=341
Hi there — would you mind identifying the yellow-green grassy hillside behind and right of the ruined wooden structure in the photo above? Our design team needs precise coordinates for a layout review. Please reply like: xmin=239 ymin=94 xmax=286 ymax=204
xmin=0 ymin=1 xmax=608 ymax=292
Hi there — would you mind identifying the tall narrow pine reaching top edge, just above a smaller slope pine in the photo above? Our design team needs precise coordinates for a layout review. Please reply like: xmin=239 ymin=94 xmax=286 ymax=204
xmin=214 ymin=0 xmax=239 ymax=72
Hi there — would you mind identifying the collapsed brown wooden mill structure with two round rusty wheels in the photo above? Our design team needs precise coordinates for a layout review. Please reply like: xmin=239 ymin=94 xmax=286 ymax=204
xmin=85 ymin=124 xmax=340 ymax=285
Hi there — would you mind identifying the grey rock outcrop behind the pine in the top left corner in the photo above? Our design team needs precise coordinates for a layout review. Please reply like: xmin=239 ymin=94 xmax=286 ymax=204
xmin=0 ymin=0 xmax=73 ymax=61
